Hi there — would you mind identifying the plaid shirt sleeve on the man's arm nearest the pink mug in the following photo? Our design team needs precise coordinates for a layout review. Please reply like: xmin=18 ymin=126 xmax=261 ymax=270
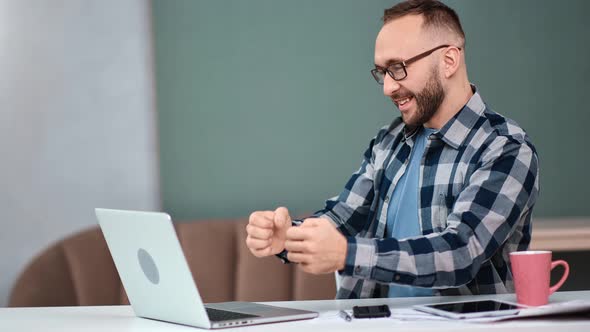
xmin=341 ymin=138 xmax=539 ymax=288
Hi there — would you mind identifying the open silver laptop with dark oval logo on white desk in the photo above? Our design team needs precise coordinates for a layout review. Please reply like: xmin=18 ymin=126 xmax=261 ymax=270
xmin=95 ymin=209 xmax=318 ymax=329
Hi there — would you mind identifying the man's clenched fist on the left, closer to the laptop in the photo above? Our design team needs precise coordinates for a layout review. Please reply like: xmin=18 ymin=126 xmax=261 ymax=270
xmin=246 ymin=207 xmax=291 ymax=257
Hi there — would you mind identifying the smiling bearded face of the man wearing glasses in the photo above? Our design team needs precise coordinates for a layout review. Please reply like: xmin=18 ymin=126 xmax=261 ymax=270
xmin=375 ymin=15 xmax=445 ymax=126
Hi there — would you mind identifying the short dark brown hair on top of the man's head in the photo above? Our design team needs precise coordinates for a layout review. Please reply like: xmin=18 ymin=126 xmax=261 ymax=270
xmin=383 ymin=0 xmax=465 ymax=46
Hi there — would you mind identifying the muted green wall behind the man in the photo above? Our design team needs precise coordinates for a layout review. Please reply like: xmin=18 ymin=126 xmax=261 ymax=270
xmin=152 ymin=0 xmax=590 ymax=223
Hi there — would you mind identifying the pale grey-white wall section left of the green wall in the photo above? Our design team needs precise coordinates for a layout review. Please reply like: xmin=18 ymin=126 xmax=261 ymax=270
xmin=0 ymin=0 xmax=161 ymax=306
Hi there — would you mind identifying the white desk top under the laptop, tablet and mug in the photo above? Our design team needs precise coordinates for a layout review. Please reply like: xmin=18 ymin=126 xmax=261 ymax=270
xmin=0 ymin=291 xmax=590 ymax=332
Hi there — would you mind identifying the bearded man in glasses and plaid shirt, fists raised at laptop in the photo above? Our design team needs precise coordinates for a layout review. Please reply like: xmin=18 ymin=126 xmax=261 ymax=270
xmin=246 ymin=1 xmax=539 ymax=298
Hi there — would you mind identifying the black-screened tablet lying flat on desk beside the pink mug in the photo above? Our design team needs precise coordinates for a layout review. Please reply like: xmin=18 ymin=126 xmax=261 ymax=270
xmin=413 ymin=300 xmax=525 ymax=319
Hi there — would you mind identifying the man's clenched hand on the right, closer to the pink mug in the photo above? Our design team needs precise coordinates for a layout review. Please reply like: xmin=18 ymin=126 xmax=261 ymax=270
xmin=285 ymin=218 xmax=347 ymax=274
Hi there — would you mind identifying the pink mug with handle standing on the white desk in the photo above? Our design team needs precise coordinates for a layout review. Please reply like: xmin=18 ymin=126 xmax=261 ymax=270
xmin=510 ymin=251 xmax=570 ymax=306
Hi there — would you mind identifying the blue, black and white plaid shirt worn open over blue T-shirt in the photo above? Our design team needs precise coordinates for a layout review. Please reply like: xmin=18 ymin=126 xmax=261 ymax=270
xmin=314 ymin=87 xmax=539 ymax=298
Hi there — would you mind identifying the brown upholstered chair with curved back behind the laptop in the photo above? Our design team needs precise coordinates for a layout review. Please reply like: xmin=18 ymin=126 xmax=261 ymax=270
xmin=9 ymin=220 xmax=336 ymax=307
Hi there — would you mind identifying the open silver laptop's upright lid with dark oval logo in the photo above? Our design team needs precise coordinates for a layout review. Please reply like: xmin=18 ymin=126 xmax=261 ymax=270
xmin=96 ymin=209 xmax=211 ymax=328
